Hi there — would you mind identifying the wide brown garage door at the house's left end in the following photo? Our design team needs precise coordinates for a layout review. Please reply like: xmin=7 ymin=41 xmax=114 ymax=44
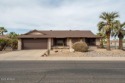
xmin=23 ymin=39 xmax=47 ymax=49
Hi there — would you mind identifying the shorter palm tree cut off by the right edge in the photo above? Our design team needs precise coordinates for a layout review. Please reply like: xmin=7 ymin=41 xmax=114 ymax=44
xmin=112 ymin=20 xmax=125 ymax=50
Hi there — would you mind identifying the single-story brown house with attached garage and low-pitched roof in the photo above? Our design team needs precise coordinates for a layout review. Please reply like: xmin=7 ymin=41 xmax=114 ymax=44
xmin=18 ymin=30 xmax=100 ymax=50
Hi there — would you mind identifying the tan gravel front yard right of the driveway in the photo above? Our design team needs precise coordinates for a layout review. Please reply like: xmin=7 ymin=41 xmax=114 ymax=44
xmin=49 ymin=49 xmax=125 ymax=57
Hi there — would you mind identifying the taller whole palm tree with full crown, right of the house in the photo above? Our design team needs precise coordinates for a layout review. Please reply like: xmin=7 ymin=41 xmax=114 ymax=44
xmin=98 ymin=12 xmax=119 ymax=50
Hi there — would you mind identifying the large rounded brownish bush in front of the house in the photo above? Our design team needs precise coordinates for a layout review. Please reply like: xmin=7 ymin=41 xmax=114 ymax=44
xmin=72 ymin=42 xmax=89 ymax=52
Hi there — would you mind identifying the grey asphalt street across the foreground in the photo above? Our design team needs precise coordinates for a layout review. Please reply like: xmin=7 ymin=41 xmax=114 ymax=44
xmin=0 ymin=61 xmax=125 ymax=83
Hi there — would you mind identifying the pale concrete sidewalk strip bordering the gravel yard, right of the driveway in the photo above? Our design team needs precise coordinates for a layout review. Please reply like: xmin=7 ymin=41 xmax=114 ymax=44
xmin=35 ymin=57 xmax=125 ymax=61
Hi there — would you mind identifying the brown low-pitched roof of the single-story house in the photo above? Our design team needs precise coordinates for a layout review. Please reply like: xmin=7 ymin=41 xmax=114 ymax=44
xmin=18 ymin=30 xmax=97 ymax=38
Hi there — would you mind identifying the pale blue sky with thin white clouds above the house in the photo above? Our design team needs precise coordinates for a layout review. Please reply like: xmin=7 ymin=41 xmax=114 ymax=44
xmin=0 ymin=0 xmax=125 ymax=34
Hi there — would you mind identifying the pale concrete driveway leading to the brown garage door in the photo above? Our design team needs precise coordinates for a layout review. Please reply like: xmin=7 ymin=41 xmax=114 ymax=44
xmin=0 ymin=50 xmax=46 ymax=60
